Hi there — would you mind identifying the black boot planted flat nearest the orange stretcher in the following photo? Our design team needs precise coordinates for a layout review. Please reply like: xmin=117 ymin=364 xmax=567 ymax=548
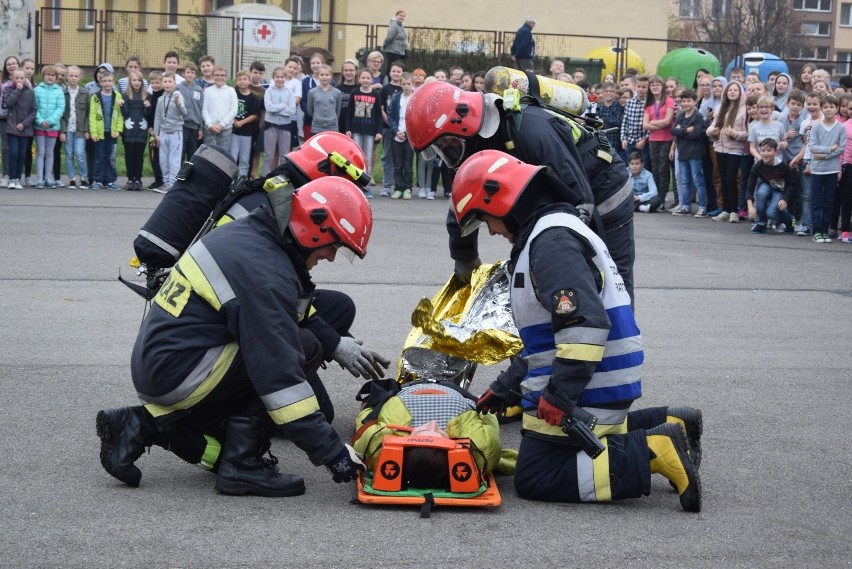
xmin=216 ymin=417 xmax=305 ymax=497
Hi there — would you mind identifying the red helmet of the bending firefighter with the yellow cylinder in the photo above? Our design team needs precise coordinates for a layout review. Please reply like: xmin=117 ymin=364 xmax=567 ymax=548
xmin=405 ymin=81 xmax=499 ymax=168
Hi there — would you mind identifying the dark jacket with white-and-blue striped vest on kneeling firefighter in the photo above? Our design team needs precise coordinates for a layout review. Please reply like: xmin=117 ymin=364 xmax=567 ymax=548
xmin=501 ymin=205 xmax=644 ymax=440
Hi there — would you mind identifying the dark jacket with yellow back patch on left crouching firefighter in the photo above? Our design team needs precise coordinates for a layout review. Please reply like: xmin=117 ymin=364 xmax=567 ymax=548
xmin=131 ymin=204 xmax=342 ymax=465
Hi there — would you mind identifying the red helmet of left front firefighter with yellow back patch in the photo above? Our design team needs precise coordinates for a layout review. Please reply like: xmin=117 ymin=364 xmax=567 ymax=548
xmin=290 ymin=178 xmax=373 ymax=261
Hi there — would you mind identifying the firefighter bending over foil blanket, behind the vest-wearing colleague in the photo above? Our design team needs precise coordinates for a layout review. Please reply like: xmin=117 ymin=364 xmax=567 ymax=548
xmin=405 ymin=81 xmax=635 ymax=306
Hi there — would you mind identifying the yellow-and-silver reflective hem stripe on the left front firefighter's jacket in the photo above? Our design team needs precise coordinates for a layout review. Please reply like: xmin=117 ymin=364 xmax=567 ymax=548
xmin=139 ymin=342 xmax=240 ymax=417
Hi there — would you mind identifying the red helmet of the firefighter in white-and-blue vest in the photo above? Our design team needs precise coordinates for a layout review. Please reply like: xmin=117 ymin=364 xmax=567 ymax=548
xmin=453 ymin=150 xmax=546 ymax=235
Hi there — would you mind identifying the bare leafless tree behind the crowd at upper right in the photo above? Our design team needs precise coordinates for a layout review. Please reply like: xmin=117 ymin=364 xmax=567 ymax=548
xmin=680 ymin=0 xmax=809 ymax=61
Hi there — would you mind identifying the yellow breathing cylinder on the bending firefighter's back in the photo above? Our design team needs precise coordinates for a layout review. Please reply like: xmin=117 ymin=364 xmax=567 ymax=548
xmin=485 ymin=65 xmax=589 ymax=115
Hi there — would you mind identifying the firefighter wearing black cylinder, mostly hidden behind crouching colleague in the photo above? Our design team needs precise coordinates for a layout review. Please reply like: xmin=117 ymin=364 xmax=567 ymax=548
xmin=127 ymin=132 xmax=389 ymax=423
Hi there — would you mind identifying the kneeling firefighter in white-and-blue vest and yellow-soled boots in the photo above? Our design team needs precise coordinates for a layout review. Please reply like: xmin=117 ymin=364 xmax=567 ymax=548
xmin=452 ymin=150 xmax=701 ymax=512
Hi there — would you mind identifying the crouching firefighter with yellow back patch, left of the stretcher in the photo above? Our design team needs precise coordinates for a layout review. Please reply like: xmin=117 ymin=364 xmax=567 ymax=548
xmin=96 ymin=177 xmax=378 ymax=496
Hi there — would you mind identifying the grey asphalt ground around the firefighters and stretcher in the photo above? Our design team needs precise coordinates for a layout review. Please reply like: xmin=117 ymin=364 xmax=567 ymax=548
xmin=0 ymin=184 xmax=852 ymax=568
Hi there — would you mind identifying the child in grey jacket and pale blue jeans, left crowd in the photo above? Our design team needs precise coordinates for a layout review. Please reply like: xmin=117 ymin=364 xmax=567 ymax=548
xmin=154 ymin=73 xmax=186 ymax=193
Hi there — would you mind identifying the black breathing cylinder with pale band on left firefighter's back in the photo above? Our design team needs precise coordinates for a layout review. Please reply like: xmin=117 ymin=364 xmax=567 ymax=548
xmin=133 ymin=144 xmax=239 ymax=269
